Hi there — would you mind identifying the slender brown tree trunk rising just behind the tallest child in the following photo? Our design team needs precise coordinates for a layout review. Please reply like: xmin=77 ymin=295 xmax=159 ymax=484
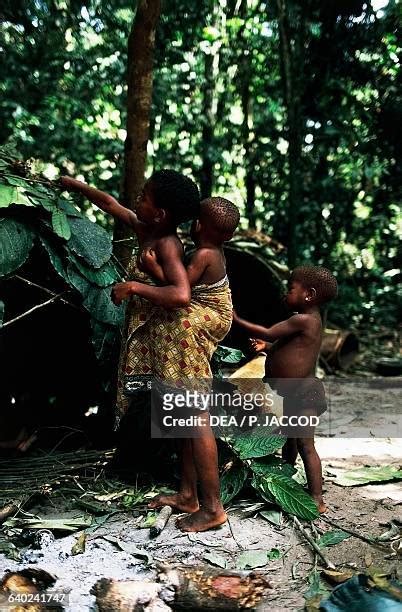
xmin=114 ymin=0 xmax=160 ymax=265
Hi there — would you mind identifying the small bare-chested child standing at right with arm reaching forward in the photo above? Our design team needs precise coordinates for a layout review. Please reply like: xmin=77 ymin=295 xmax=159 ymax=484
xmin=233 ymin=266 xmax=337 ymax=512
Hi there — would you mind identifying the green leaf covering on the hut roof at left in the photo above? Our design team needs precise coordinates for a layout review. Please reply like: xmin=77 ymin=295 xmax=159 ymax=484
xmin=0 ymin=149 xmax=124 ymax=368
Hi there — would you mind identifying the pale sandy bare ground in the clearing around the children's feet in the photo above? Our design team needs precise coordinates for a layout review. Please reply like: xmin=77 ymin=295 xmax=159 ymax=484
xmin=0 ymin=382 xmax=402 ymax=612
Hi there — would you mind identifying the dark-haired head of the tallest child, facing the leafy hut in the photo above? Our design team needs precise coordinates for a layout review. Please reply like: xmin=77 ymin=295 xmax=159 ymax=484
xmin=136 ymin=170 xmax=200 ymax=227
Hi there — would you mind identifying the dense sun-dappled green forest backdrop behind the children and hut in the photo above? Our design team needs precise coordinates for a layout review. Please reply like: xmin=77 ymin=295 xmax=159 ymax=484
xmin=0 ymin=0 xmax=402 ymax=326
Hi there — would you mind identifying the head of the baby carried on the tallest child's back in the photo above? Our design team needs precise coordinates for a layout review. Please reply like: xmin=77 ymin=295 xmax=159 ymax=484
xmin=191 ymin=197 xmax=240 ymax=244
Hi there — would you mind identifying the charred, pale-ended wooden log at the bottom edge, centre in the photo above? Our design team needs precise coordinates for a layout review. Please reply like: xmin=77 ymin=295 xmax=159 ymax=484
xmin=91 ymin=566 xmax=271 ymax=612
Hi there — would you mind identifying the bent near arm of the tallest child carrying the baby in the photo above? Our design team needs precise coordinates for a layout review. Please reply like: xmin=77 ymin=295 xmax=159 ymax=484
xmin=112 ymin=240 xmax=191 ymax=308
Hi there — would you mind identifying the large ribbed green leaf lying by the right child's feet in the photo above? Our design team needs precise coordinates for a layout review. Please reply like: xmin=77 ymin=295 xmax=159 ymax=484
xmin=259 ymin=474 xmax=319 ymax=521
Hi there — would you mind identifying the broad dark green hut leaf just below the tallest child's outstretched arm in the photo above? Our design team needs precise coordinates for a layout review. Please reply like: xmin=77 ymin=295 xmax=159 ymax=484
xmin=69 ymin=217 xmax=112 ymax=268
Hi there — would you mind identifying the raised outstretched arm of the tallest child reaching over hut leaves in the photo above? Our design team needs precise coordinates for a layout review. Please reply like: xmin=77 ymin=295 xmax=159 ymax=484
xmin=60 ymin=176 xmax=143 ymax=232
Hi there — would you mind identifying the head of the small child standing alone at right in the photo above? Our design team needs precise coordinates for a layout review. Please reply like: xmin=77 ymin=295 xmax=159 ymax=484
xmin=286 ymin=266 xmax=338 ymax=310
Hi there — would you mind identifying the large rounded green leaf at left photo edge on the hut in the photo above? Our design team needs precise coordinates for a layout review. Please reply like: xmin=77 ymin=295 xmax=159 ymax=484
xmin=0 ymin=218 xmax=34 ymax=276
